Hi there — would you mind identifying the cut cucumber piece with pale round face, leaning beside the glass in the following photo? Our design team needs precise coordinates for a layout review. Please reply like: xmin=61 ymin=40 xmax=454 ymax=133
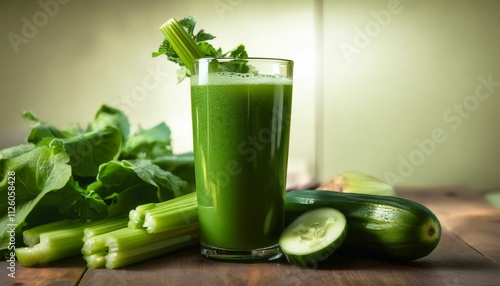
xmin=279 ymin=208 xmax=347 ymax=267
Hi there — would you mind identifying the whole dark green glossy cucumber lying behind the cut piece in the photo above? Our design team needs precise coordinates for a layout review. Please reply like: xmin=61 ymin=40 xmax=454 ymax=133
xmin=285 ymin=190 xmax=441 ymax=261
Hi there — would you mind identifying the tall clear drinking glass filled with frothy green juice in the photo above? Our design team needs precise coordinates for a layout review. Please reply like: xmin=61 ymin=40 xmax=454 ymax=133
xmin=191 ymin=58 xmax=293 ymax=261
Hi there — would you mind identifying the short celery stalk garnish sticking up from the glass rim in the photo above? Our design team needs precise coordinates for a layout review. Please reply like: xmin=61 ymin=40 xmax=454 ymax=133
xmin=160 ymin=18 xmax=205 ymax=73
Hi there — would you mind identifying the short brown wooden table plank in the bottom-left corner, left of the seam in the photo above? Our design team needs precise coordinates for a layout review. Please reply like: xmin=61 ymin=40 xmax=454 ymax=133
xmin=0 ymin=257 xmax=87 ymax=286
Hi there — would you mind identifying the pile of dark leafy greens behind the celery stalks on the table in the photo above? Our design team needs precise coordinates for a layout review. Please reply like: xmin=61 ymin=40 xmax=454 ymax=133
xmin=0 ymin=105 xmax=194 ymax=252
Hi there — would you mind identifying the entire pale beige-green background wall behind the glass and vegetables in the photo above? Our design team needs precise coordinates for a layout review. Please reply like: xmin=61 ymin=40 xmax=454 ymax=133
xmin=0 ymin=0 xmax=500 ymax=190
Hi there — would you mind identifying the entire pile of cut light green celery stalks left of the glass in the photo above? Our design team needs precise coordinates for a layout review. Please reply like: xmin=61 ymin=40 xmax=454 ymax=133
xmin=16 ymin=193 xmax=199 ymax=269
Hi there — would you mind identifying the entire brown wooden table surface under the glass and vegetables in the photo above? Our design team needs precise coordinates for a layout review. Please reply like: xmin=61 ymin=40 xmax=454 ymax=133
xmin=0 ymin=187 xmax=500 ymax=286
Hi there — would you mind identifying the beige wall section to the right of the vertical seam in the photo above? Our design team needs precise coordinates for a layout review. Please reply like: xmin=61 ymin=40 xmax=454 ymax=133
xmin=319 ymin=0 xmax=500 ymax=192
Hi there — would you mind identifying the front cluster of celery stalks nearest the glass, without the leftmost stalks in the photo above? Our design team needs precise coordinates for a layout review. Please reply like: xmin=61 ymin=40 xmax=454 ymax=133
xmin=82 ymin=193 xmax=199 ymax=269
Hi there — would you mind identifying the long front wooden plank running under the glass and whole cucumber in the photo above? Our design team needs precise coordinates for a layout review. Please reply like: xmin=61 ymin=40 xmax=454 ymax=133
xmin=80 ymin=226 xmax=500 ymax=286
